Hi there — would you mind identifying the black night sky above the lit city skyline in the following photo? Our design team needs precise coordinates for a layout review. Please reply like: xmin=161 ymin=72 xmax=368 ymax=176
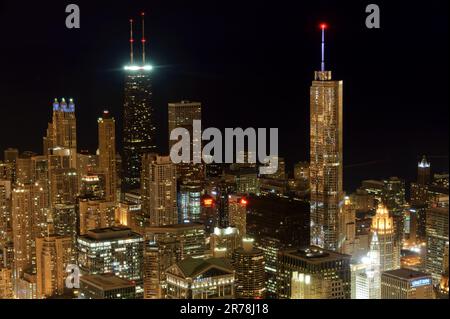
xmin=0 ymin=0 xmax=450 ymax=190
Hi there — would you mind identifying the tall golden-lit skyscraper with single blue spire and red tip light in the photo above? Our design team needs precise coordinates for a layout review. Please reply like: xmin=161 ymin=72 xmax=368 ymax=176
xmin=310 ymin=24 xmax=344 ymax=250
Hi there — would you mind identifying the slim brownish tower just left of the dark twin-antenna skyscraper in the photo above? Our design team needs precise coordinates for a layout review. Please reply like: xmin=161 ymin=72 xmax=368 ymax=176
xmin=98 ymin=111 xmax=117 ymax=202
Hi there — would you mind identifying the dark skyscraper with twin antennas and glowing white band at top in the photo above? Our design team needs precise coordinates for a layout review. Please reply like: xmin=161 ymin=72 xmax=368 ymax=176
xmin=122 ymin=14 xmax=156 ymax=189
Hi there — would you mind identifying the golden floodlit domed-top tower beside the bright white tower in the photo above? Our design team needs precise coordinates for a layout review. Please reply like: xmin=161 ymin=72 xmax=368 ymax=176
xmin=371 ymin=204 xmax=400 ymax=272
